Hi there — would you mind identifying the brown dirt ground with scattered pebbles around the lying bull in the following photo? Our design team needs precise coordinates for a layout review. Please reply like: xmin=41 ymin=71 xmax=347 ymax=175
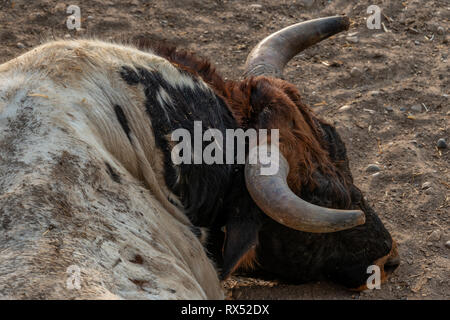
xmin=0 ymin=0 xmax=450 ymax=299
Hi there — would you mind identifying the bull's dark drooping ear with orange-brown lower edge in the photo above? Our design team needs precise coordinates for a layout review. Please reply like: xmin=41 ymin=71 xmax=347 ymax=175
xmin=221 ymin=207 xmax=261 ymax=280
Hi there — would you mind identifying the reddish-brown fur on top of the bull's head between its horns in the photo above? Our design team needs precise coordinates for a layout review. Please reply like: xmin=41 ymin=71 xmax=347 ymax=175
xmin=226 ymin=76 xmax=335 ymax=194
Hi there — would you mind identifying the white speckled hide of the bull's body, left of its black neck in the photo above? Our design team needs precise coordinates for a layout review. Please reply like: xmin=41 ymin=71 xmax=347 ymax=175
xmin=0 ymin=41 xmax=223 ymax=299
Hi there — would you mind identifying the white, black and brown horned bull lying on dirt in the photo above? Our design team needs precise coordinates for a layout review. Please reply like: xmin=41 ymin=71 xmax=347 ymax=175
xmin=0 ymin=16 xmax=399 ymax=299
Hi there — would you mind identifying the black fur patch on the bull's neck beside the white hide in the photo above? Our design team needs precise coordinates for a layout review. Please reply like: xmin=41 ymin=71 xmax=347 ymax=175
xmin=120 ymin=67 xmax=237 ymax=227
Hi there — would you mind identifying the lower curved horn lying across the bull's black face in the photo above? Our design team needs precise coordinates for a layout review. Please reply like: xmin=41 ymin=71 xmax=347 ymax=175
xmin=245 ymin=145 xmax=365 ymax=233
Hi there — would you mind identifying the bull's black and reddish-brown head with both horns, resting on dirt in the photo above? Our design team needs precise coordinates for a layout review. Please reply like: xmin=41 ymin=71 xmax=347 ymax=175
xmin=223 ymin=16 xmax=399 ymax=288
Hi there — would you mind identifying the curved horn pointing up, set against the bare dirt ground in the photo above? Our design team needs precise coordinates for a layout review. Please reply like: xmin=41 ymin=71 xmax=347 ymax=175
xmin=243 ymin=16 xmax=350 ymax=78
